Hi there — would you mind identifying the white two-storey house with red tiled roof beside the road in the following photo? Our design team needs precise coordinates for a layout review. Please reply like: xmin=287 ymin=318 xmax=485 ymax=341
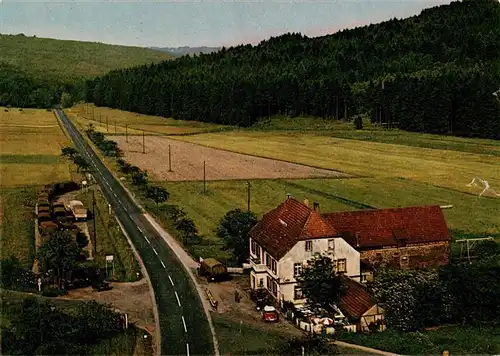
xmin=249 ymin=198 xmax=360 ymax=305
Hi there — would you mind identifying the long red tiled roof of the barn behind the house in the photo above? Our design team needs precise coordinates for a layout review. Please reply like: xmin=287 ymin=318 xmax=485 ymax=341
xmin=322 ymin=205 xmax=451 ymax=248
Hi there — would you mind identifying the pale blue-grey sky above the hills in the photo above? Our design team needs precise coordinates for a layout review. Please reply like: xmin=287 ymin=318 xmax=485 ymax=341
xmin=0 ymin=0 xmax=450 ymax=50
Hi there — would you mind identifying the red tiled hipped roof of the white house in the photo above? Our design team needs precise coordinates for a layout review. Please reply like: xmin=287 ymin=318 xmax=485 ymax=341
xmin=249 ymin=198 xmax=338 ymax=260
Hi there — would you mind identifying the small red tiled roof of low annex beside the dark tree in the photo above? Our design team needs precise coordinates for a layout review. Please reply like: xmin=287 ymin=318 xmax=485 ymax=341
xmin=339 ymin=276 xmax=375 ymax=320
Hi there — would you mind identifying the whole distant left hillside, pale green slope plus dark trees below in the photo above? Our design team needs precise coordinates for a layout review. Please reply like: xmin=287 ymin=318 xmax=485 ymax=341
xmin=0 ymin=35 xmax=170 ymax=107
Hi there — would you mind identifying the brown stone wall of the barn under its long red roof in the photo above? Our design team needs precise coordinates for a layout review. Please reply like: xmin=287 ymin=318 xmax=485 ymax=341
xmin=361 ymin=241 xmax=450 ymax=269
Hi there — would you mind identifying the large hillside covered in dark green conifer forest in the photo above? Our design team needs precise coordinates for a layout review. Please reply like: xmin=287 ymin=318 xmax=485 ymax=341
xmin=86 ymin=0 xmax=500 ymax=139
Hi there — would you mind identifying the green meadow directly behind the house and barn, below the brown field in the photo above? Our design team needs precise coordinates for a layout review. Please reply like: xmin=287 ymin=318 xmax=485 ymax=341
xmin=158 ymin=178 xmax=500 ymax=260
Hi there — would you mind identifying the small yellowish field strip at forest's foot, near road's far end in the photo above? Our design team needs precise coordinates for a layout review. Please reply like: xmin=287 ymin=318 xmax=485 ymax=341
xmin=65 ymin=104 xmax=228 ymax=135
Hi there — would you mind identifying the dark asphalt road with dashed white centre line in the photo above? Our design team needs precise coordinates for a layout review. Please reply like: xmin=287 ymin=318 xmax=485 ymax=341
xmin=56 ymin=109 xmax=214 ymax=356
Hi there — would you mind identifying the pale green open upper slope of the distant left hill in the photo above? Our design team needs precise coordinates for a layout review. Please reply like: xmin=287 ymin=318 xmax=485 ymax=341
xmin=0 ymin=35 xmax=171 ymax=79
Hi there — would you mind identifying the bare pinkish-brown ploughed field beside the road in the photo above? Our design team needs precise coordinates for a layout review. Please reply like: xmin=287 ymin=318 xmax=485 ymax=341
xmin=109 ymin=136 xmax=348 ymax=181
